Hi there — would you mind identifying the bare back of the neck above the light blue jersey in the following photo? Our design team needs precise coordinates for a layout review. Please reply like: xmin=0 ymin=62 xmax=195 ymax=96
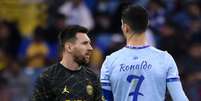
xmin=127 ymin=34 xmax=146 ymax=46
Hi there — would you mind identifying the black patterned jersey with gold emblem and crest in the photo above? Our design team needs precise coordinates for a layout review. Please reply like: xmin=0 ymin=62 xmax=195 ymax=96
xmin=31 ymin=63 xmax=101 ymax=101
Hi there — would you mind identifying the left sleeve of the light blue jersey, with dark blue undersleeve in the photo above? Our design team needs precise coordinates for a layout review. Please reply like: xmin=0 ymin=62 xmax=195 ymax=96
xmin=100 ymin=56 xmax=113 ymax=101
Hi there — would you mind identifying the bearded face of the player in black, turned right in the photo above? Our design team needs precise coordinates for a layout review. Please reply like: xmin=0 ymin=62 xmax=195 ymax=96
xmin=72 ymin=33 xmax=93 ymax=65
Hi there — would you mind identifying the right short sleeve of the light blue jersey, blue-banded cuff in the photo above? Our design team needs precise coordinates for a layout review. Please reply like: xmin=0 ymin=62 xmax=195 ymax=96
xmin=165 ymin=53 xmax=180 ymax=83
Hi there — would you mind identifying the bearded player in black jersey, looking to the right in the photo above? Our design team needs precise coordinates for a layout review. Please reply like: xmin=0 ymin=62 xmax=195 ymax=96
xmin=31 ymin=25 xmax=101 ymax=101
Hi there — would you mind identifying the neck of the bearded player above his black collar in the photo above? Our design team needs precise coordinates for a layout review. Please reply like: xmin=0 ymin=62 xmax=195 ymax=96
xmin=60 ymin=54 xmax=80 ymax=71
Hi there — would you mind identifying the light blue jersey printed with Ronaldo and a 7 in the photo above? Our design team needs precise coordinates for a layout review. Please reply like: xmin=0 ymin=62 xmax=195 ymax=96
xmin=100 ymin=46 xmax=187 ymax=101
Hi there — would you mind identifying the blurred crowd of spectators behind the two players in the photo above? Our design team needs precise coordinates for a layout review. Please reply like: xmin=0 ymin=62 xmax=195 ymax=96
xmin=0 ymin=0 xmax=201 ymax=101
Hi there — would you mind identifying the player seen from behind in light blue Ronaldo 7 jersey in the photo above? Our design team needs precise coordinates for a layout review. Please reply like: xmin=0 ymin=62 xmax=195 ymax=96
xmin=100 ymin=5 xmax=188 ymax=101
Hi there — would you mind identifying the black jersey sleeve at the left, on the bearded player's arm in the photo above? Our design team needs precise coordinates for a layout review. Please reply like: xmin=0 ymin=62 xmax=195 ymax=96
xmin=31 ymin=74 xmax=51 ymax=101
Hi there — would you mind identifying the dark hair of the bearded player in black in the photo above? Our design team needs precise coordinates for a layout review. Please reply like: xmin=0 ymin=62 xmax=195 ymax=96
xmin=58 ymin=25 xmax=88 ymax=51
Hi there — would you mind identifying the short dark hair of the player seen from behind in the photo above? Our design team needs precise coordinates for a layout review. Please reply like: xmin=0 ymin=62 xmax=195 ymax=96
xmin=122 ymin=5 xmax=148 ymax=33
